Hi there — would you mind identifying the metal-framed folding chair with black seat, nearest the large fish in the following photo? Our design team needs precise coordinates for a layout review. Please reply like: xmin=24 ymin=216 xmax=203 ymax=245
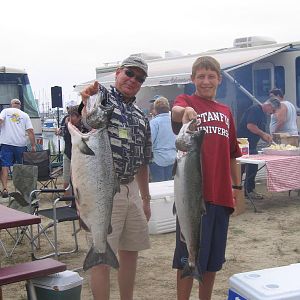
xmin=31 ymin=189 xmax=80 ymax=260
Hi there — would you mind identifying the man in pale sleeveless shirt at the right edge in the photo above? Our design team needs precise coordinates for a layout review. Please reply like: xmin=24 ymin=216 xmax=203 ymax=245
xmin=269 ymin=88 xmax=298 ymax=135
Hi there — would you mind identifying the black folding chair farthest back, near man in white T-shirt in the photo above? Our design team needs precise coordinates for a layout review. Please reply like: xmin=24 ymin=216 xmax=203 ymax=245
xmin=23 ymin=150 xmax=62 ymax=189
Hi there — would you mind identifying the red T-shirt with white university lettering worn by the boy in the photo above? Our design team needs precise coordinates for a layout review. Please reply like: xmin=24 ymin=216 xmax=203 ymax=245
xmin=174 ymin=94 xmax=241 ymax=208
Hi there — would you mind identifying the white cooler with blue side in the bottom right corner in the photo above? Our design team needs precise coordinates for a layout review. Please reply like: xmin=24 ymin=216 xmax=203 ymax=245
xmin=228 ymin=264 xmax=300 ymax=300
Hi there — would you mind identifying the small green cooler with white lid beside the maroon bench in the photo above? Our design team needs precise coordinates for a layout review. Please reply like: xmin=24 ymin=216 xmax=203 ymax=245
xmin=27 ymin=271 xmax=83 ymax=300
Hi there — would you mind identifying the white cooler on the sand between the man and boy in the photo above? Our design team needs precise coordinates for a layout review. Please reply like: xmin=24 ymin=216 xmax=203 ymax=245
xmin=148 ymin=180 xmax=176 ymax=234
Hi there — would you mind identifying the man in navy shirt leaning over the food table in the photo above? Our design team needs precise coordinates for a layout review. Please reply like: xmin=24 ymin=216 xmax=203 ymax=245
xmin=237 ymin=98 xmax=280 ymax=199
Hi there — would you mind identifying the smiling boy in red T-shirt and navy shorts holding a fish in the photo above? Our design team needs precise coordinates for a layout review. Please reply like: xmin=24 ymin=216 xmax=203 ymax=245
xmin=172 ymin=56 xmax=241 ymax=300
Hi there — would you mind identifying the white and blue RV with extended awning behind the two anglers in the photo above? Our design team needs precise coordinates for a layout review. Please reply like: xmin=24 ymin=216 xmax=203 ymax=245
xmin=75 ymin=36 xmax=300 ymax=126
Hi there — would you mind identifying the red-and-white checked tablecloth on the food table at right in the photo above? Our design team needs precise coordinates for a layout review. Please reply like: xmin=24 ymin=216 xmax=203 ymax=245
xmin=244 ymin=154 xmax=300 ymax=192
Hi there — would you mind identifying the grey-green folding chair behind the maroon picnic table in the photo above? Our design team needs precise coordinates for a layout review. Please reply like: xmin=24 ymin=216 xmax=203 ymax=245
xmin=0 ymin=164 xmax=38 ymax=257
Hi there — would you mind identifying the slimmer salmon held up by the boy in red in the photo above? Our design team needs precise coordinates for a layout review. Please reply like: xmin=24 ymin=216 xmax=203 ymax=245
xmin=174 ymin=120 xmax=206 ymax=281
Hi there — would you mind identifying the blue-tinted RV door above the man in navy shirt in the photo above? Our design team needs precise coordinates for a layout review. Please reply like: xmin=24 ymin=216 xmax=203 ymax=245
xmin=252 ymin=62 xmax=274 ymax=102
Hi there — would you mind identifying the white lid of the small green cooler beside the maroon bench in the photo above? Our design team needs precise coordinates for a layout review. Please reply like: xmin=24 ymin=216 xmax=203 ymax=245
xmin=32 ymin=270 xmax=83 ymax=291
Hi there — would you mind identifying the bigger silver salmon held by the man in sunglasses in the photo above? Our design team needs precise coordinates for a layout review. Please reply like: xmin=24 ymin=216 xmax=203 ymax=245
xmin=68 ymin=92 xmax=120 ymax=270
